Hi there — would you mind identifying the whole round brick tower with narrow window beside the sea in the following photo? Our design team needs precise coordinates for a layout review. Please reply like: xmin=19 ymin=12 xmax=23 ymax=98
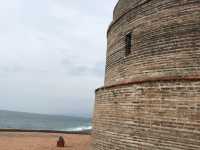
xmin=93 ymin=0 xmax=200 ymax=150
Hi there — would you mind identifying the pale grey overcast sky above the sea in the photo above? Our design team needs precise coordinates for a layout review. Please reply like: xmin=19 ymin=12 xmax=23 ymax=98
xmin=0 ymin=0 xmax=117 ymax=116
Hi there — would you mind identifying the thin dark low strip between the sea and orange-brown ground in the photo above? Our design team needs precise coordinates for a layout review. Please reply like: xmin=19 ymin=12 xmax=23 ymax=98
xmin=0 ymin=129 xmax=92 ymax=135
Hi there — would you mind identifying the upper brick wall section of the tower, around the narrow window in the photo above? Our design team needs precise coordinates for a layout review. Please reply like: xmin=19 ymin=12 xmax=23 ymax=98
xmin=105 ymin=0 xmax=200 ymax=85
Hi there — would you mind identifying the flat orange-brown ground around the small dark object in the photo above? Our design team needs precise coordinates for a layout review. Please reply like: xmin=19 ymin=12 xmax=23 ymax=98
xmin=0 ymin=132 xmax=91 ymax=150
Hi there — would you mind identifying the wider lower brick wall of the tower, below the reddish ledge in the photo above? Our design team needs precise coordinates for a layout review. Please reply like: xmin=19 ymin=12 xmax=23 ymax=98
xmin=93 ymin=81 xmax=200 ymax=150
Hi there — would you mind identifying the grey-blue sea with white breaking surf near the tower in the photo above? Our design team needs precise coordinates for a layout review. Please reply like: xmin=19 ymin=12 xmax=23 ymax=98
xmin=0 ymin=110 xmax=92 ymax=132
